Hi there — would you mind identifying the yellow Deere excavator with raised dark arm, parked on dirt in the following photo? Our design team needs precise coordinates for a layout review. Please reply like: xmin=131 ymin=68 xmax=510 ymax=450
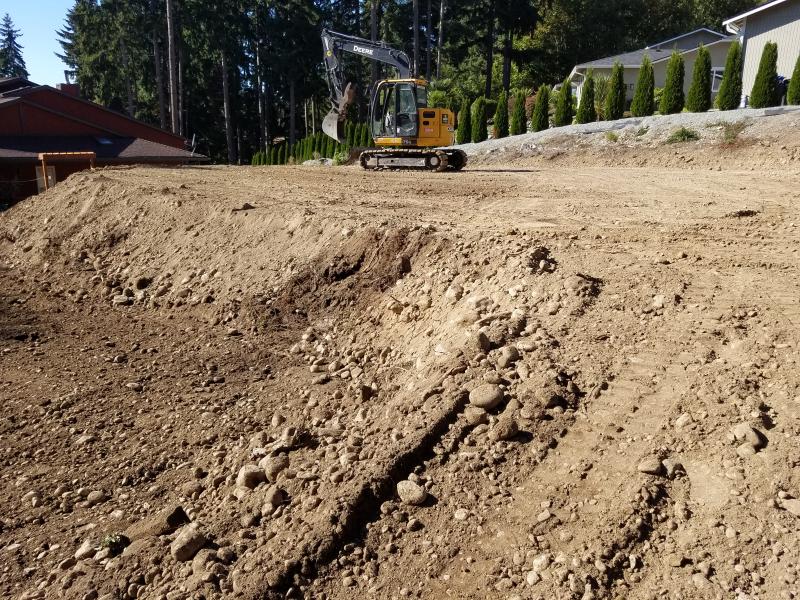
xmin=322 ymin=29 xmax=467 ymax=172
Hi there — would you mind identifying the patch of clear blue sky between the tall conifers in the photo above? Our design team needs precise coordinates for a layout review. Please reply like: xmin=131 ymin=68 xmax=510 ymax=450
xmin=5 ymin=0 xmax=74 ymax=85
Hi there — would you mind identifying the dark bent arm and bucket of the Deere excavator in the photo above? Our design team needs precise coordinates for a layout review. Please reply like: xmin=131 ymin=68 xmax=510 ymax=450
xmin=322 ymin=29 xmax=411 ymax=143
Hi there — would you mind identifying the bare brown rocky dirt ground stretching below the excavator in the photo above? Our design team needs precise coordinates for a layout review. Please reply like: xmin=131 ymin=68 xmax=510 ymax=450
xmin=0 ymin=118 xmax=800 ymax=600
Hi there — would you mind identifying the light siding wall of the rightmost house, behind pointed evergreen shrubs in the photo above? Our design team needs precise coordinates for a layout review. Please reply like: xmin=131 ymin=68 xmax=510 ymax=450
xmin=742 ymin=0 xmax=800 ymax=97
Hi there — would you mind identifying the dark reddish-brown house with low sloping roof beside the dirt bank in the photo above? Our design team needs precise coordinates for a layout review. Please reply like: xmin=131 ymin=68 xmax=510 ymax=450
xmin=0 ymin=77 xmax=207 ymax=205
